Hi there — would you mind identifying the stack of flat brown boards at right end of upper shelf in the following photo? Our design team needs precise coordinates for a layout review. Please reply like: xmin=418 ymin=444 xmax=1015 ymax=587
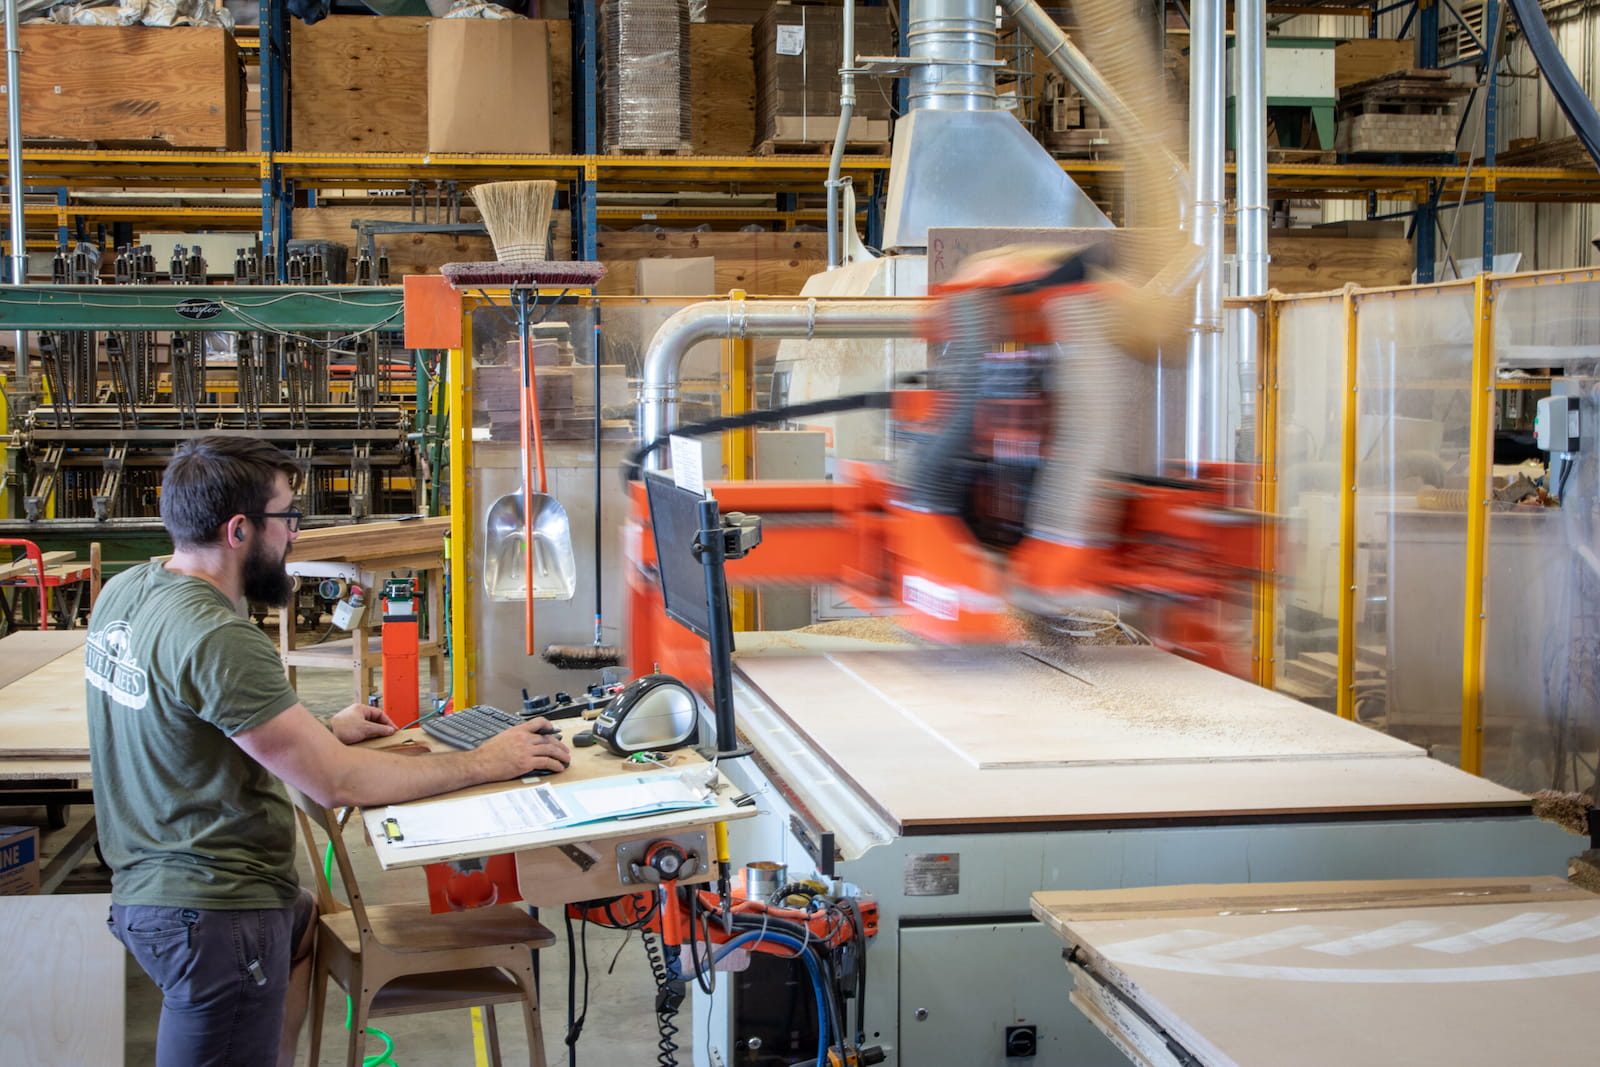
xmin=1334 ymin=70 xmax=1472 ymax=155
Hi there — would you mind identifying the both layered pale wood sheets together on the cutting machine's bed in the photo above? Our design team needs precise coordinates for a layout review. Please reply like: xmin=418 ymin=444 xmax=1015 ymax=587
xmin=736 ymin=633 xmax=1530 ymax=833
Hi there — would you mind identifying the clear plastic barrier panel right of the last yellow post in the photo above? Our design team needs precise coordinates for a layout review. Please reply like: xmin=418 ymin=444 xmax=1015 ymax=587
xmin=1483 ymin=280 xmax=1600 ymax=792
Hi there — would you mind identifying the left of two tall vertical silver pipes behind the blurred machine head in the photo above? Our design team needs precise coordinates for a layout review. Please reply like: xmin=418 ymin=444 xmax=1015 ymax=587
xmin=1184 ymin=0 xmax=1227 ymax=470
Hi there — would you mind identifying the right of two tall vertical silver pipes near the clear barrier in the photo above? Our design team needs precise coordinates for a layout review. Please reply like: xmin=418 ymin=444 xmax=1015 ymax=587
xmin=1232 ymin=0 xmax=1267 ymax=454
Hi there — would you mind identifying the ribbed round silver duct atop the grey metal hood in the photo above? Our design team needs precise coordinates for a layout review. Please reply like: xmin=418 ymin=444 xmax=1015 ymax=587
xmin=906 ymin=0 xmax=995 ymax=110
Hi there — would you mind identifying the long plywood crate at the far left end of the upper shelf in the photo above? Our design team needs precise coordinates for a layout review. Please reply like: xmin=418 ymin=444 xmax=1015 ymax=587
xmin=0 ymin=26 xmax=245 ymax=152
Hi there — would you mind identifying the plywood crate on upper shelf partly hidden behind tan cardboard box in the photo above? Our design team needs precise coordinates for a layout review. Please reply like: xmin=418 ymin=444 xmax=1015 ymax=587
xmin=290 ymin=14 xmax=573 ymax=155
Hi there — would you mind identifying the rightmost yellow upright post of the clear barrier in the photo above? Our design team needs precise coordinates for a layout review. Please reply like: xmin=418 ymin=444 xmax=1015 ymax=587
xmin=1461 ymin=274 xmax=1494 ymax=774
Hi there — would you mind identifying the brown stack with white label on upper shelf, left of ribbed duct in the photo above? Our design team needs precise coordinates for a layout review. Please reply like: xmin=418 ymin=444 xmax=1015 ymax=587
xmin=754 ymin=3 xmax=894 ymax=152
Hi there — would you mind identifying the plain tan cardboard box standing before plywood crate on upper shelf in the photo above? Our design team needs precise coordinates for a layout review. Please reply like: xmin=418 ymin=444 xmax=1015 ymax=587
xmin=427 ymin=19 xmax=550 ymax=154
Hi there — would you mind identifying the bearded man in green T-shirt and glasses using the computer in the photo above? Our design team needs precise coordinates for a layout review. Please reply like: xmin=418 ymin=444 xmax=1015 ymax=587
xmin=85 ymin=434 xmax=571 ymax=1067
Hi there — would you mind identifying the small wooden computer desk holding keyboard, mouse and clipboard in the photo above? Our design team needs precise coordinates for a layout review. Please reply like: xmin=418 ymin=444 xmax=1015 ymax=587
xmin=362 ymin=735 xmax=757 ymax=907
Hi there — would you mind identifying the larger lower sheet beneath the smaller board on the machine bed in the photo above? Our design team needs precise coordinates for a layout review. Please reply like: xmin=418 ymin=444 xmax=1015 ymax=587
xmin=736 ymin=649 xmax=1528 ymax=832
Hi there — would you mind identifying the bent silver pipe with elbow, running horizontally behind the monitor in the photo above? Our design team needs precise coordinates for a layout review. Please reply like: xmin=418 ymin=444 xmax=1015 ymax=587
xmin=638 ymin=298 xmax=928 ymax=470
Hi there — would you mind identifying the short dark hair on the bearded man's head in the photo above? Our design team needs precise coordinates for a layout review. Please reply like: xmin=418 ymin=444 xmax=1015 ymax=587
xmin=162 ymin=434 xmax=299 ymax=547
